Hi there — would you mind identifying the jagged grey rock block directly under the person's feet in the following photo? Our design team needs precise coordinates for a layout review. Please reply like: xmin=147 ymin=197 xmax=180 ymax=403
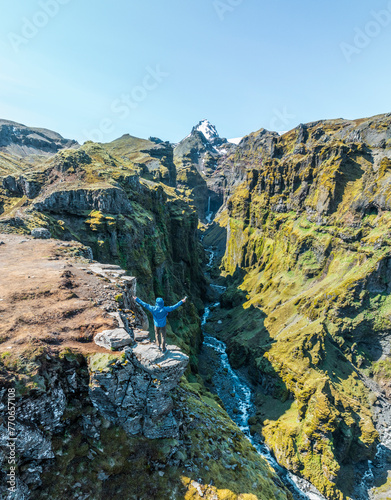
xmin=89 ymin=343 xmax=189 ymax=439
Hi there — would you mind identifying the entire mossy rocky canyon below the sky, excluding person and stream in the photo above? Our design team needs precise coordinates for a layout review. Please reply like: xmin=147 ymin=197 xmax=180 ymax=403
xmin=0 ymin=114 xmax=391 ymax=500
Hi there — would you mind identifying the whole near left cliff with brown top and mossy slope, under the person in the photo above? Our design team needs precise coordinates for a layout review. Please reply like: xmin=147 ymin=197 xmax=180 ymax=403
xmin=0 ymin=234 xmax=291 ymax=500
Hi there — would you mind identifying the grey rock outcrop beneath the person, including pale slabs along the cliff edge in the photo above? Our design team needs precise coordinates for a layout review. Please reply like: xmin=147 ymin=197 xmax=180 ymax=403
xmin=89 ymin=263 xmax=189 ymax=439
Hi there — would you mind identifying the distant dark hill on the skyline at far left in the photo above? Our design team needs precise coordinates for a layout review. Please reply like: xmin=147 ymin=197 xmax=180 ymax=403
xmin=0 ymin=120 xmax=79 ymax=157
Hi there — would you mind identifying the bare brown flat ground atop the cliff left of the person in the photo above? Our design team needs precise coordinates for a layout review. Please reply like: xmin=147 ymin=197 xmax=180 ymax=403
xmin=0 ymin=234 xmax=118 ymax=356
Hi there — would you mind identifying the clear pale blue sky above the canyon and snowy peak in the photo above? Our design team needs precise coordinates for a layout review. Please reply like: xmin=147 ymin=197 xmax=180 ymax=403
xmin=0 ymin=0 xmax=391 ymax=142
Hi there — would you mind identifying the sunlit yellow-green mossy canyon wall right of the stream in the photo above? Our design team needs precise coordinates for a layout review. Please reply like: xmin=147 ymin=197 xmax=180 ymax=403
xmin=205 ymin=115 xmax=391 ymax=499
